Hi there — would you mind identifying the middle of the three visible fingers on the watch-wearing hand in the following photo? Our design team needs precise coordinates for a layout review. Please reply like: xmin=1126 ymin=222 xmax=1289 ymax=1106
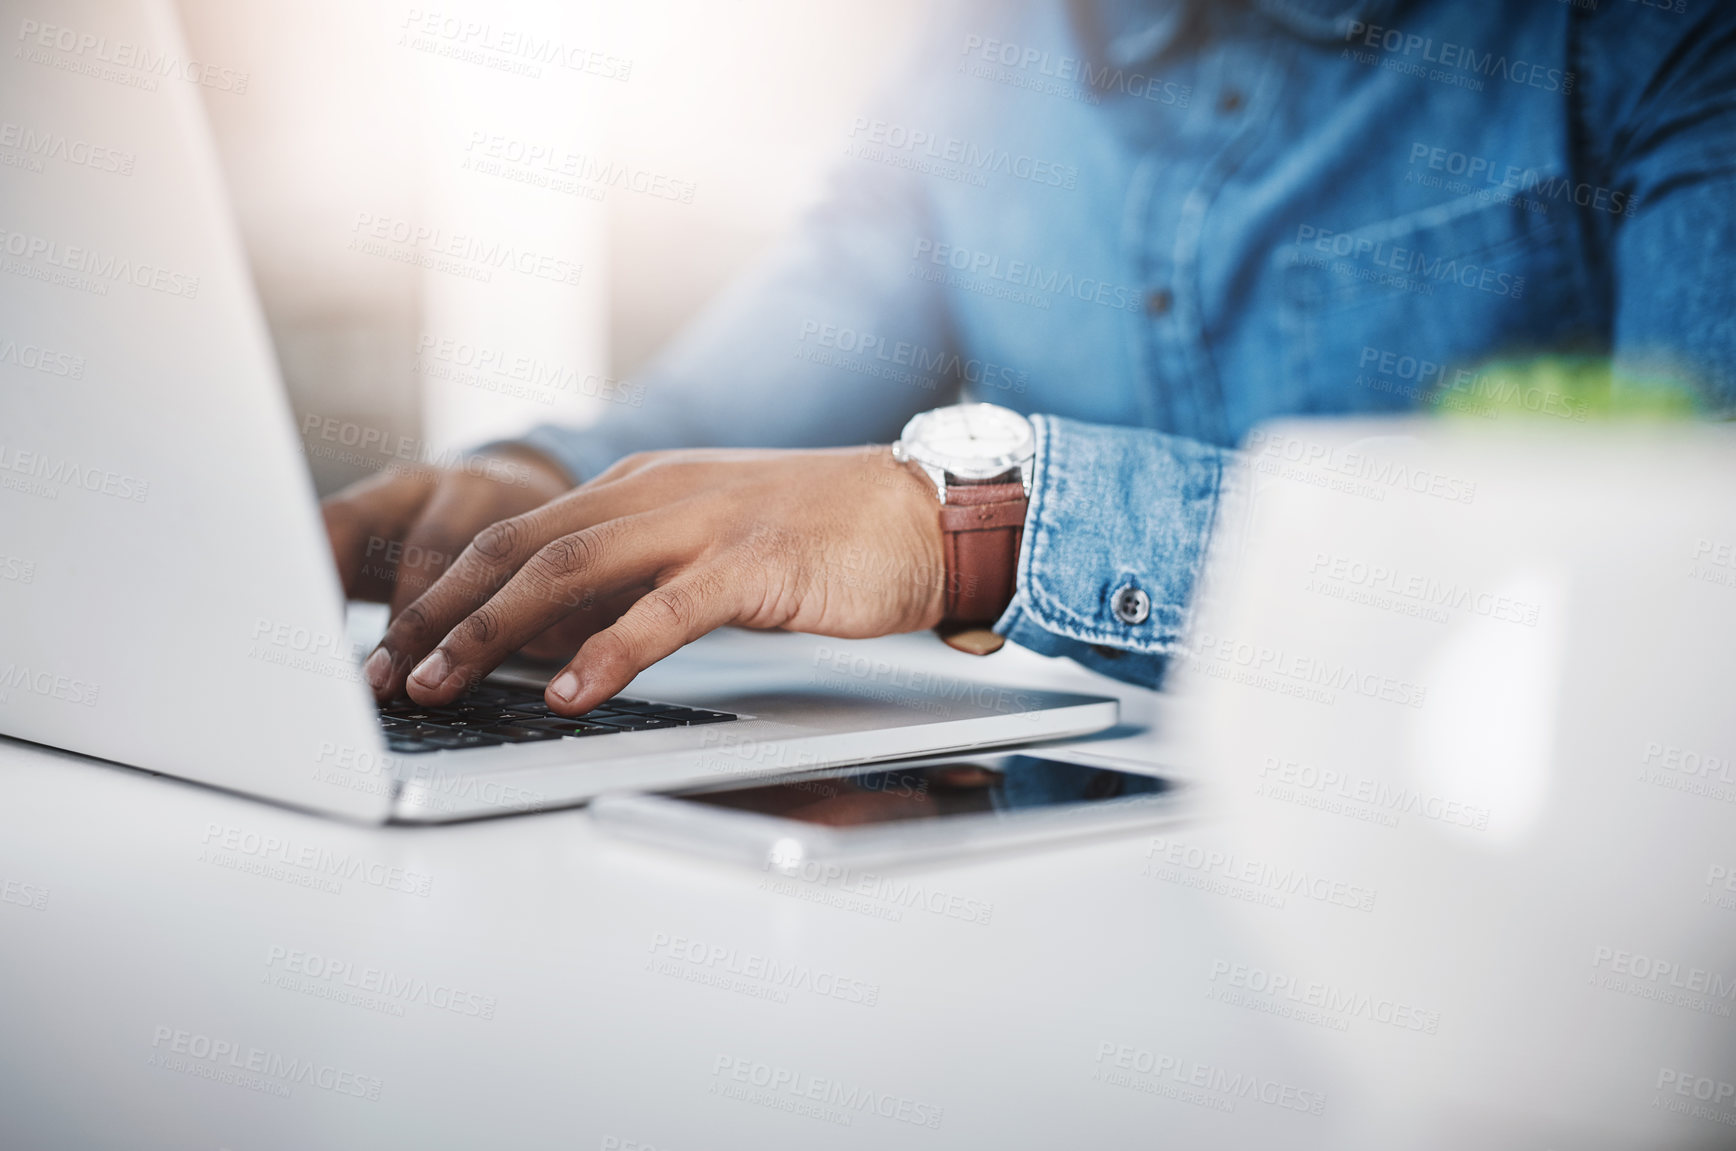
xmin=408 ymin=510 xmax=703 ymax=703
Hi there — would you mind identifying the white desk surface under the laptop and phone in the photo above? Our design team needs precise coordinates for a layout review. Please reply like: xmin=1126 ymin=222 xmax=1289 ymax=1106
xmin=0 ymin=635 xmax=1729 ymax=1151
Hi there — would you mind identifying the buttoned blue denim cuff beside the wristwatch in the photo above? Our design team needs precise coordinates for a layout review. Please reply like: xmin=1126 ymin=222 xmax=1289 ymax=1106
xmin=995 ymin=415 xmax=1233 ymax=686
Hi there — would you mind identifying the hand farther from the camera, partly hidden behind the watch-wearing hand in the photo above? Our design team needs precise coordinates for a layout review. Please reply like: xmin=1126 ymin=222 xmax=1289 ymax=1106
xmin=319 ymin=448 xmax=573 ymax=616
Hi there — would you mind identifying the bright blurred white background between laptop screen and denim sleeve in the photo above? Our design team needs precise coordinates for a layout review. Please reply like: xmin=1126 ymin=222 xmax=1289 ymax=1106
xmin=179 ymin=0 xmax=922 ymax=495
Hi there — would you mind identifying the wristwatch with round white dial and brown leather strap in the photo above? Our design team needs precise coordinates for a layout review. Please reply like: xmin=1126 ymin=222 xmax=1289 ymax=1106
xmin=892 ymin=403 xmax=1036 ymax=631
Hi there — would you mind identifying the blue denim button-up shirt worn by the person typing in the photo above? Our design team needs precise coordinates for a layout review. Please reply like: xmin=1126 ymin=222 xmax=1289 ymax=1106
xmin=513 ymin=0 xmax=1736 ymax=684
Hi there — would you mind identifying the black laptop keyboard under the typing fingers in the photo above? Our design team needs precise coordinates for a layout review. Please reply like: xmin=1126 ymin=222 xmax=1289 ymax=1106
xmin=380 ymin=684 xmax=741 ymax=755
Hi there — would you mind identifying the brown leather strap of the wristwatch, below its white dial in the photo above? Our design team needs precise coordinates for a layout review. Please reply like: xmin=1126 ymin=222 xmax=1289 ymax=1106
xmin=941 ymin=479 xmax=1029 ymax=623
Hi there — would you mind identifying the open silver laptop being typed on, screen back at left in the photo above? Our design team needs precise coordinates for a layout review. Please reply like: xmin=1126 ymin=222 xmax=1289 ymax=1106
xmin=0 ymin=0 xmax=1116 ymax=821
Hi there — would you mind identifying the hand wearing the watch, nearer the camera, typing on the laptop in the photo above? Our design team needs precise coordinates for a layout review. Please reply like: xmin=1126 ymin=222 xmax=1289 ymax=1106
xmin=365 ymin=448 xmax=944 ymax=715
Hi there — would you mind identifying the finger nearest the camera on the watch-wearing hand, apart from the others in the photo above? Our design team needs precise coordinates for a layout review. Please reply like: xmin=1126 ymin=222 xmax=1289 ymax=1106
xmin=543 ymin=566 xmax=745 ymax=715
